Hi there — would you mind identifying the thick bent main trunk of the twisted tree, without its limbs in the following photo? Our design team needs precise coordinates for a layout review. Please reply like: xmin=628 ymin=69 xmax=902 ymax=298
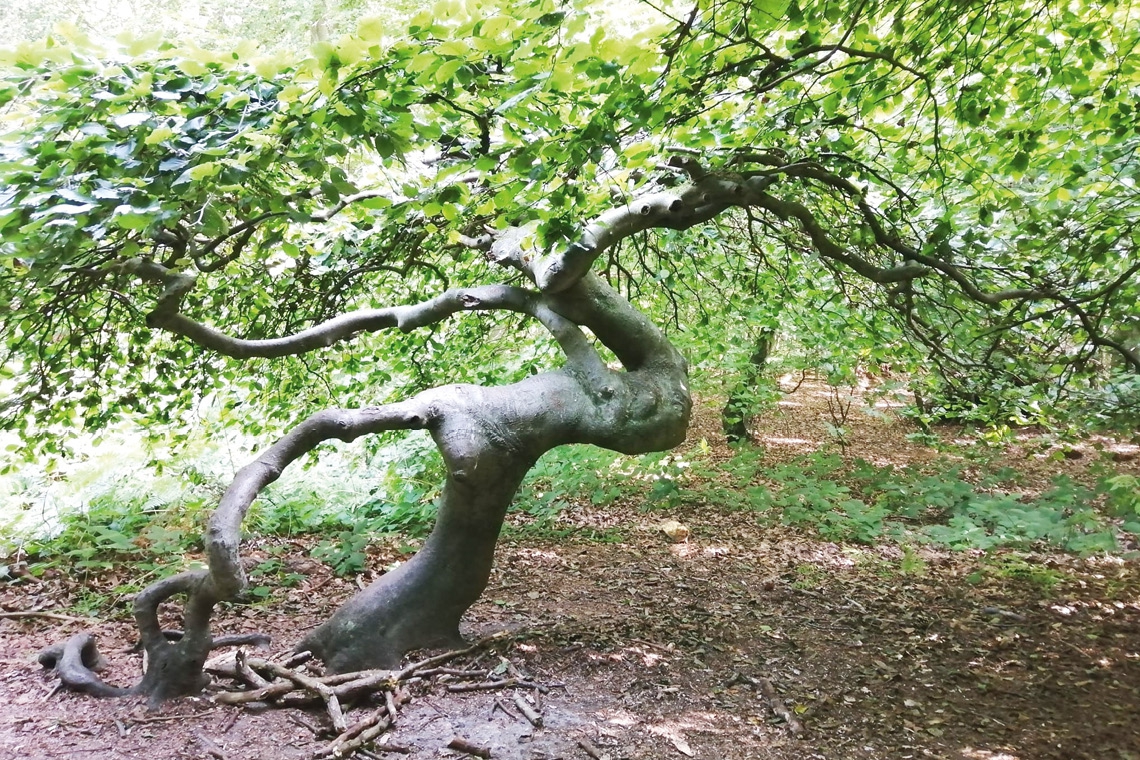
xmin=298 ymin=275 xmax=691 ymax=672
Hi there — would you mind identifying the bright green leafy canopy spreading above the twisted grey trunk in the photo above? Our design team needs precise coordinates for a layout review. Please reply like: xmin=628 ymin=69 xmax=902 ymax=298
xmin=0 ymin=0 xmax=1140 ymax=451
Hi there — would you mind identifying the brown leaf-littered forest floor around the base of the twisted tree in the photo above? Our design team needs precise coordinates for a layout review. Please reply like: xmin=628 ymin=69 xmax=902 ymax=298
xmin=0 ymin=383 xmax=1140 ymax=760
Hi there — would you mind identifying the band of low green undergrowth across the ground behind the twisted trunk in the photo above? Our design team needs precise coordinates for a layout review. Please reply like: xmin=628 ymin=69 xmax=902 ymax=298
xmin=0 ymin=412 xmax=1140 ymax=610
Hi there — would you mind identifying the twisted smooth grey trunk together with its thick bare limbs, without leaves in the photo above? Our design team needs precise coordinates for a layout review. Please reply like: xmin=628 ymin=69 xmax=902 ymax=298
xmin=43 ymin=190 xmax=693 ymax=703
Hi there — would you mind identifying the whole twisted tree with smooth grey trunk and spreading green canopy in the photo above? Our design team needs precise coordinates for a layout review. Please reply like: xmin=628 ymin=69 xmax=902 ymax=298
xmin=0 ymin=0 xmax=1140 ymax=700
